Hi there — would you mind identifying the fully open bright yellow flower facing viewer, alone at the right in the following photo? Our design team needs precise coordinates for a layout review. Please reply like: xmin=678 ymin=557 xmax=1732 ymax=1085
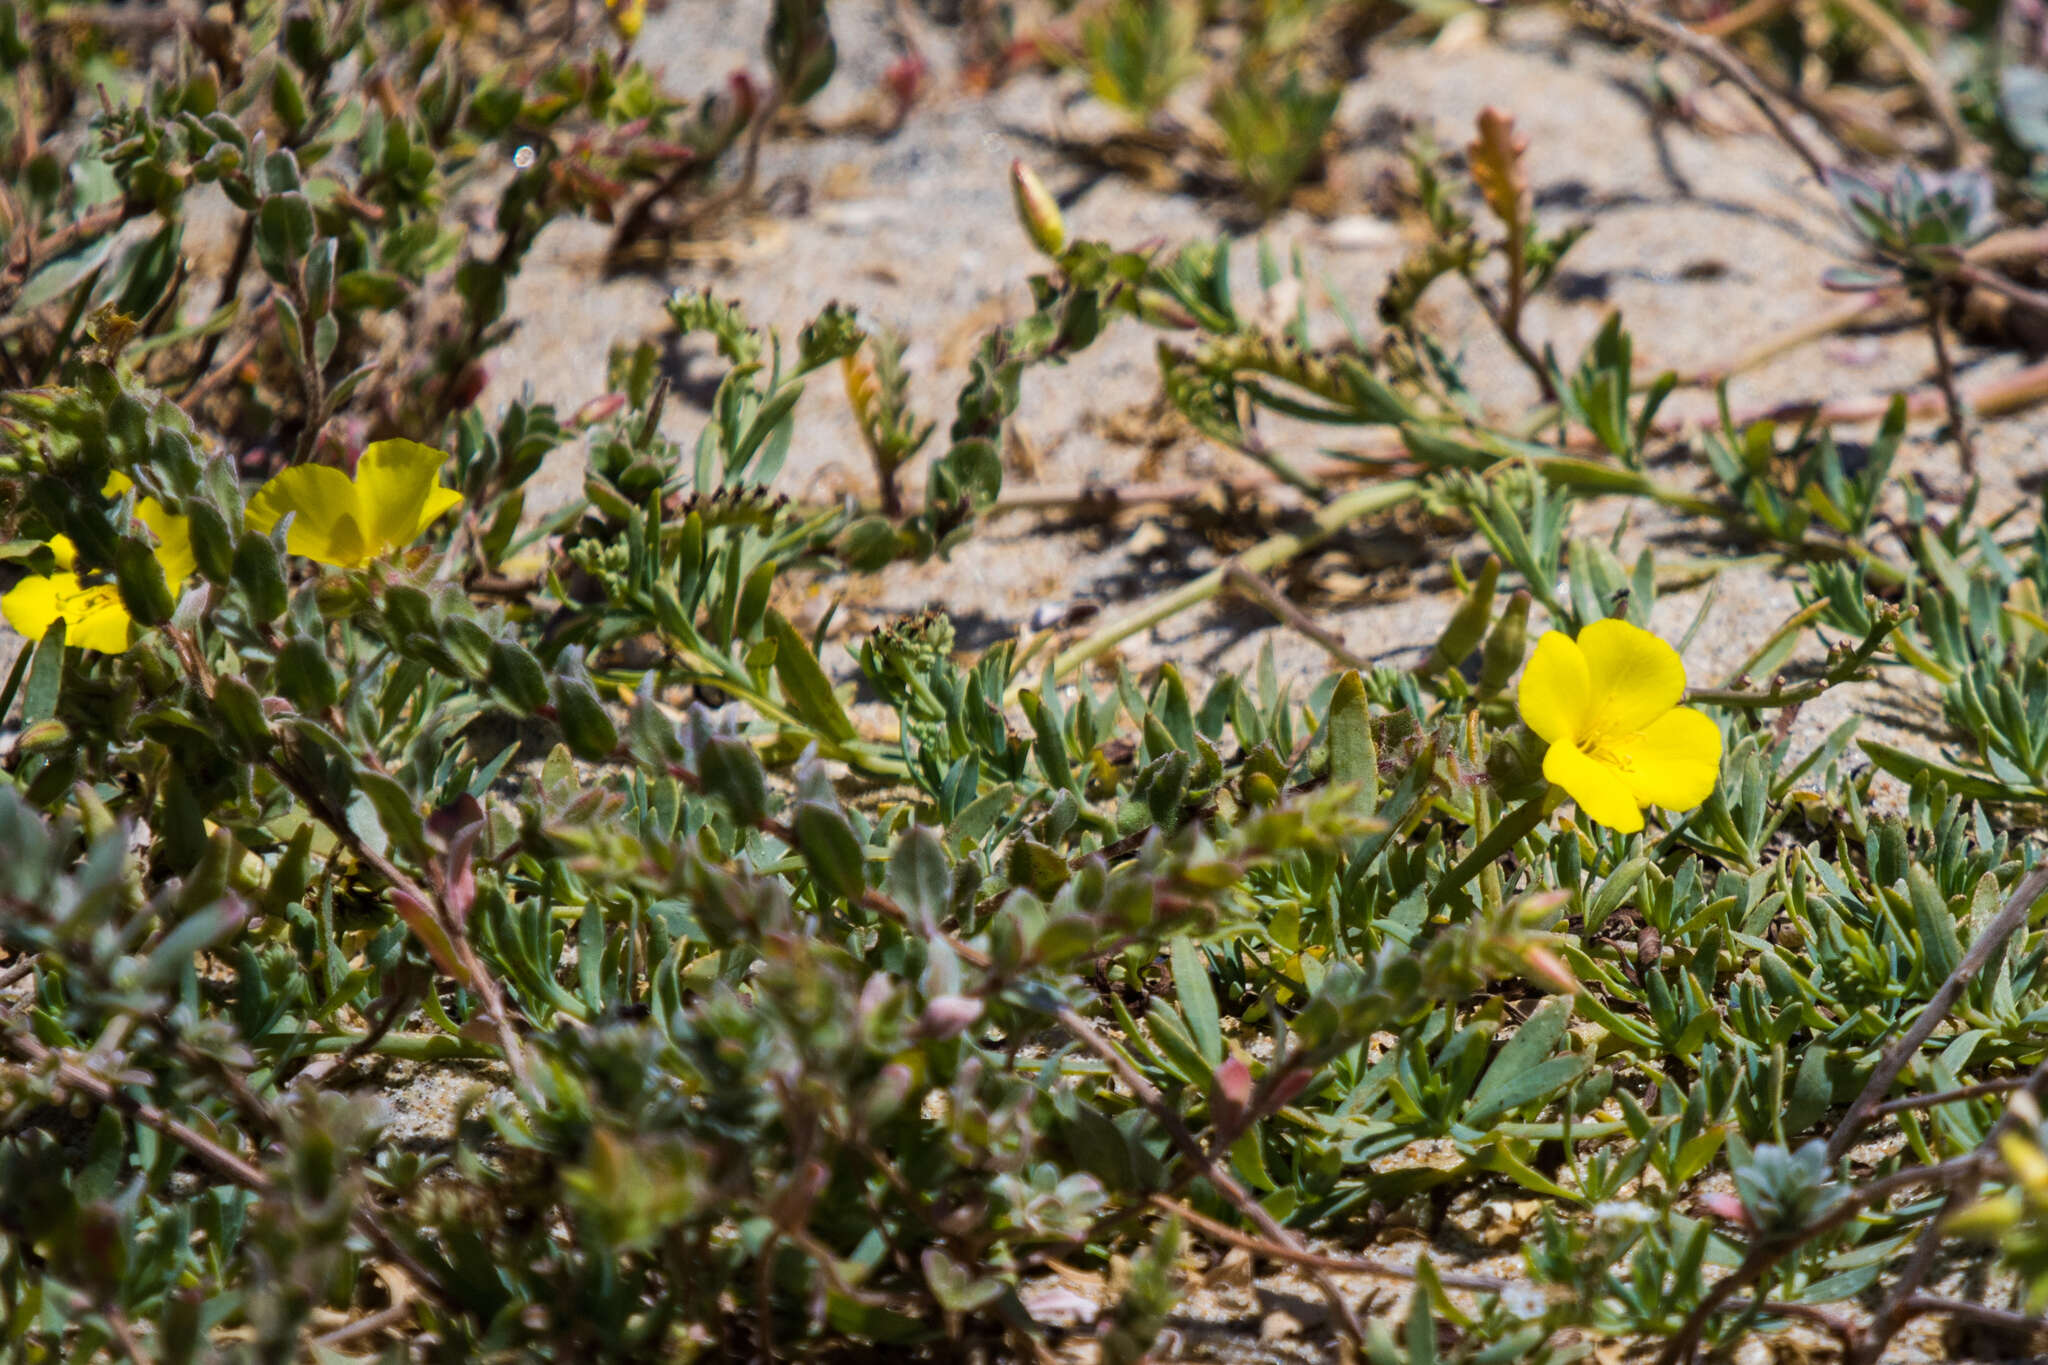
xmin=1520 ymin=620 xmax=1720 ymax=833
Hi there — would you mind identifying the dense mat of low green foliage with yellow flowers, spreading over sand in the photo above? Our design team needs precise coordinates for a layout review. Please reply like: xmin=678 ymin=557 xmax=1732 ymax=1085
xmin=0 ymin=0 xmax=2048 ymax=1365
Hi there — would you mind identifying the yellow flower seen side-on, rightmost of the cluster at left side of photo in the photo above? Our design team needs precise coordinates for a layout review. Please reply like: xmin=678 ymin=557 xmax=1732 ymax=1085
xmin=246 ymin=440 xmax=463 ymax=569
